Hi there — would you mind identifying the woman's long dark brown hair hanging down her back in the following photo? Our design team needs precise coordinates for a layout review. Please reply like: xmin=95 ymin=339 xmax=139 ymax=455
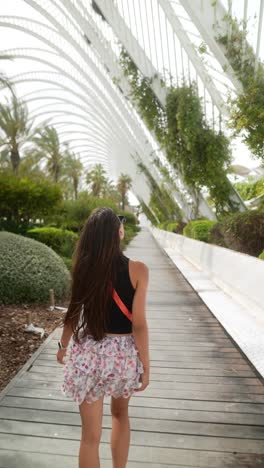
xmin=63 ymin=208 xmax=122 ymax=342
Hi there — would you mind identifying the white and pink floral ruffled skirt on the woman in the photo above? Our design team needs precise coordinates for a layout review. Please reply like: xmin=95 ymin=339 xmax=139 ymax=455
xmin=61 ymin=335 xmax=143 ymax=405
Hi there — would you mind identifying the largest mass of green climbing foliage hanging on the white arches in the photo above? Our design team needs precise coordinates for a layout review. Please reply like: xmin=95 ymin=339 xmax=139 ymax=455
xmin=165 ymin=85 xmax=237 ymax=215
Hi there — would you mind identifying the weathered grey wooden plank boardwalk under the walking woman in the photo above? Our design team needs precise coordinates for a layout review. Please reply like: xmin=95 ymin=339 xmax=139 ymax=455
xmin=0 ymin=230 xmax=264 ymax=468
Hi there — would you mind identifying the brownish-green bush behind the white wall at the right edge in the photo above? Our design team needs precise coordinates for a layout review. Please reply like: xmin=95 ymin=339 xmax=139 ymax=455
xmin=211 ymin=210 xmax=264 ymax=257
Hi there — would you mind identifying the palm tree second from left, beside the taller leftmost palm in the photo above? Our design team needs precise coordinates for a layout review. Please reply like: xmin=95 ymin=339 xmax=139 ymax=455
xmin=32 ymin=126 xmax=64 ymax=182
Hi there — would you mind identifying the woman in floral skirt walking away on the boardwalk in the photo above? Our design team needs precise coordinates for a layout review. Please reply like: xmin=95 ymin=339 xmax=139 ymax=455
xmin=57 ymin=208 xmax=149 ymax=468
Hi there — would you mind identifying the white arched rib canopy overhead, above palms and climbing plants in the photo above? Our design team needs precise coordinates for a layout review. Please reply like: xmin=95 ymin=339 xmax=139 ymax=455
xmin=0 ymin=0 xmax=264 ymax=219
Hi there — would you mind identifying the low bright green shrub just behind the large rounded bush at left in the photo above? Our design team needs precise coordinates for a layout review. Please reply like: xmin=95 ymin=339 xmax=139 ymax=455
xmin=27 ymin=227 xmax=78 ymax=258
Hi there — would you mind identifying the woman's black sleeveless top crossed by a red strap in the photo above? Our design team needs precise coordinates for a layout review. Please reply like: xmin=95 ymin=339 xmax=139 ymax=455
xmin=106 ymin=255 xmax=135 ymax=334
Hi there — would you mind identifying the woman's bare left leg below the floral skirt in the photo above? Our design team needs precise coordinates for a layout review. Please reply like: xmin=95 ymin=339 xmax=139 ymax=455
xmin=79 ymin=398 xmax=104 ymax=468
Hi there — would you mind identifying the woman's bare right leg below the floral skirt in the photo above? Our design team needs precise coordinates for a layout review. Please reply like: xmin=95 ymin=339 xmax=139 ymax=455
xmin=111 ymin=397 xmax=130 ymax=468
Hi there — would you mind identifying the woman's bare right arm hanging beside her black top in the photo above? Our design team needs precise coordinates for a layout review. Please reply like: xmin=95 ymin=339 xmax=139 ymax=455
xmin=132 ymin=262 xmax=149 ymax=390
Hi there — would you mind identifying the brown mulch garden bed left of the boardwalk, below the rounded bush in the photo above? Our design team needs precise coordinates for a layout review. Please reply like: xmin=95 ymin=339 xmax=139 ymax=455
xmin=0 ymin=304 xmax=67 ymax=391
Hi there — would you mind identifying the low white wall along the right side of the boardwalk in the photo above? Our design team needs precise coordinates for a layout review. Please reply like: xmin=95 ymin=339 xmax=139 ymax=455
xmin=152 ymin=228 xmax=264 ymax=320
